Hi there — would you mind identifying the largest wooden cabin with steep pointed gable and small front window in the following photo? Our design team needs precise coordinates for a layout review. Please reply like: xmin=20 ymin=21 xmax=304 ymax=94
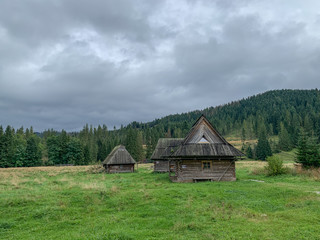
xmin=151 ymin=115 xmax=244 ymax=182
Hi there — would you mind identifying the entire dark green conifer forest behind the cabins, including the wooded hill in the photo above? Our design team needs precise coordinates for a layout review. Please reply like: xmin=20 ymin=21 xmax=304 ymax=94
xmin=0 ymin=89 xmax=320 ymax=167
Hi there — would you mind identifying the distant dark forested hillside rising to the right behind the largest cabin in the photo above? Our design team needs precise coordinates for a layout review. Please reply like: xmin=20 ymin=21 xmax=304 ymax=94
xmin=129 ymin=89 xmax=320 ymax=142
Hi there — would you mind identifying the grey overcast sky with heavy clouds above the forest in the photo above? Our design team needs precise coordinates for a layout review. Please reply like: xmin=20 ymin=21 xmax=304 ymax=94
xmin=0 ymin=0 xmax=320 ymax=131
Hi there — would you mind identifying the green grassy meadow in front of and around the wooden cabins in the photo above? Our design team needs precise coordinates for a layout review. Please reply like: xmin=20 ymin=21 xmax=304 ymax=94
xmin=0 ymin=161 xmax=320 ymax=240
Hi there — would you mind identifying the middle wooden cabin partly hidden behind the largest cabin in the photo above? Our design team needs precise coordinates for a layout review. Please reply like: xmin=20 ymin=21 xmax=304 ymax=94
xmin=151 ymin=138 xmax=183 ymax=173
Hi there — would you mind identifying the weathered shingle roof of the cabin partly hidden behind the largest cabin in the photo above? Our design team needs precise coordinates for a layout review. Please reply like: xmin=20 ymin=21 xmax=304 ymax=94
xmin=151 ymin=138 xmax=184 ymax=160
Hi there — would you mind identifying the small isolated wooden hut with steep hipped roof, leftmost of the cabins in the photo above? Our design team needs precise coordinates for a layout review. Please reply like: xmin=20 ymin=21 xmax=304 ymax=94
xmin=102 ymin=145 xmax=136 ymax=173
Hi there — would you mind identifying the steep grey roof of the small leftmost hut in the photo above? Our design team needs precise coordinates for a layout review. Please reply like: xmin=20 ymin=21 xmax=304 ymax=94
xmin=102 ymin=145 xmax=136 ymax=165
